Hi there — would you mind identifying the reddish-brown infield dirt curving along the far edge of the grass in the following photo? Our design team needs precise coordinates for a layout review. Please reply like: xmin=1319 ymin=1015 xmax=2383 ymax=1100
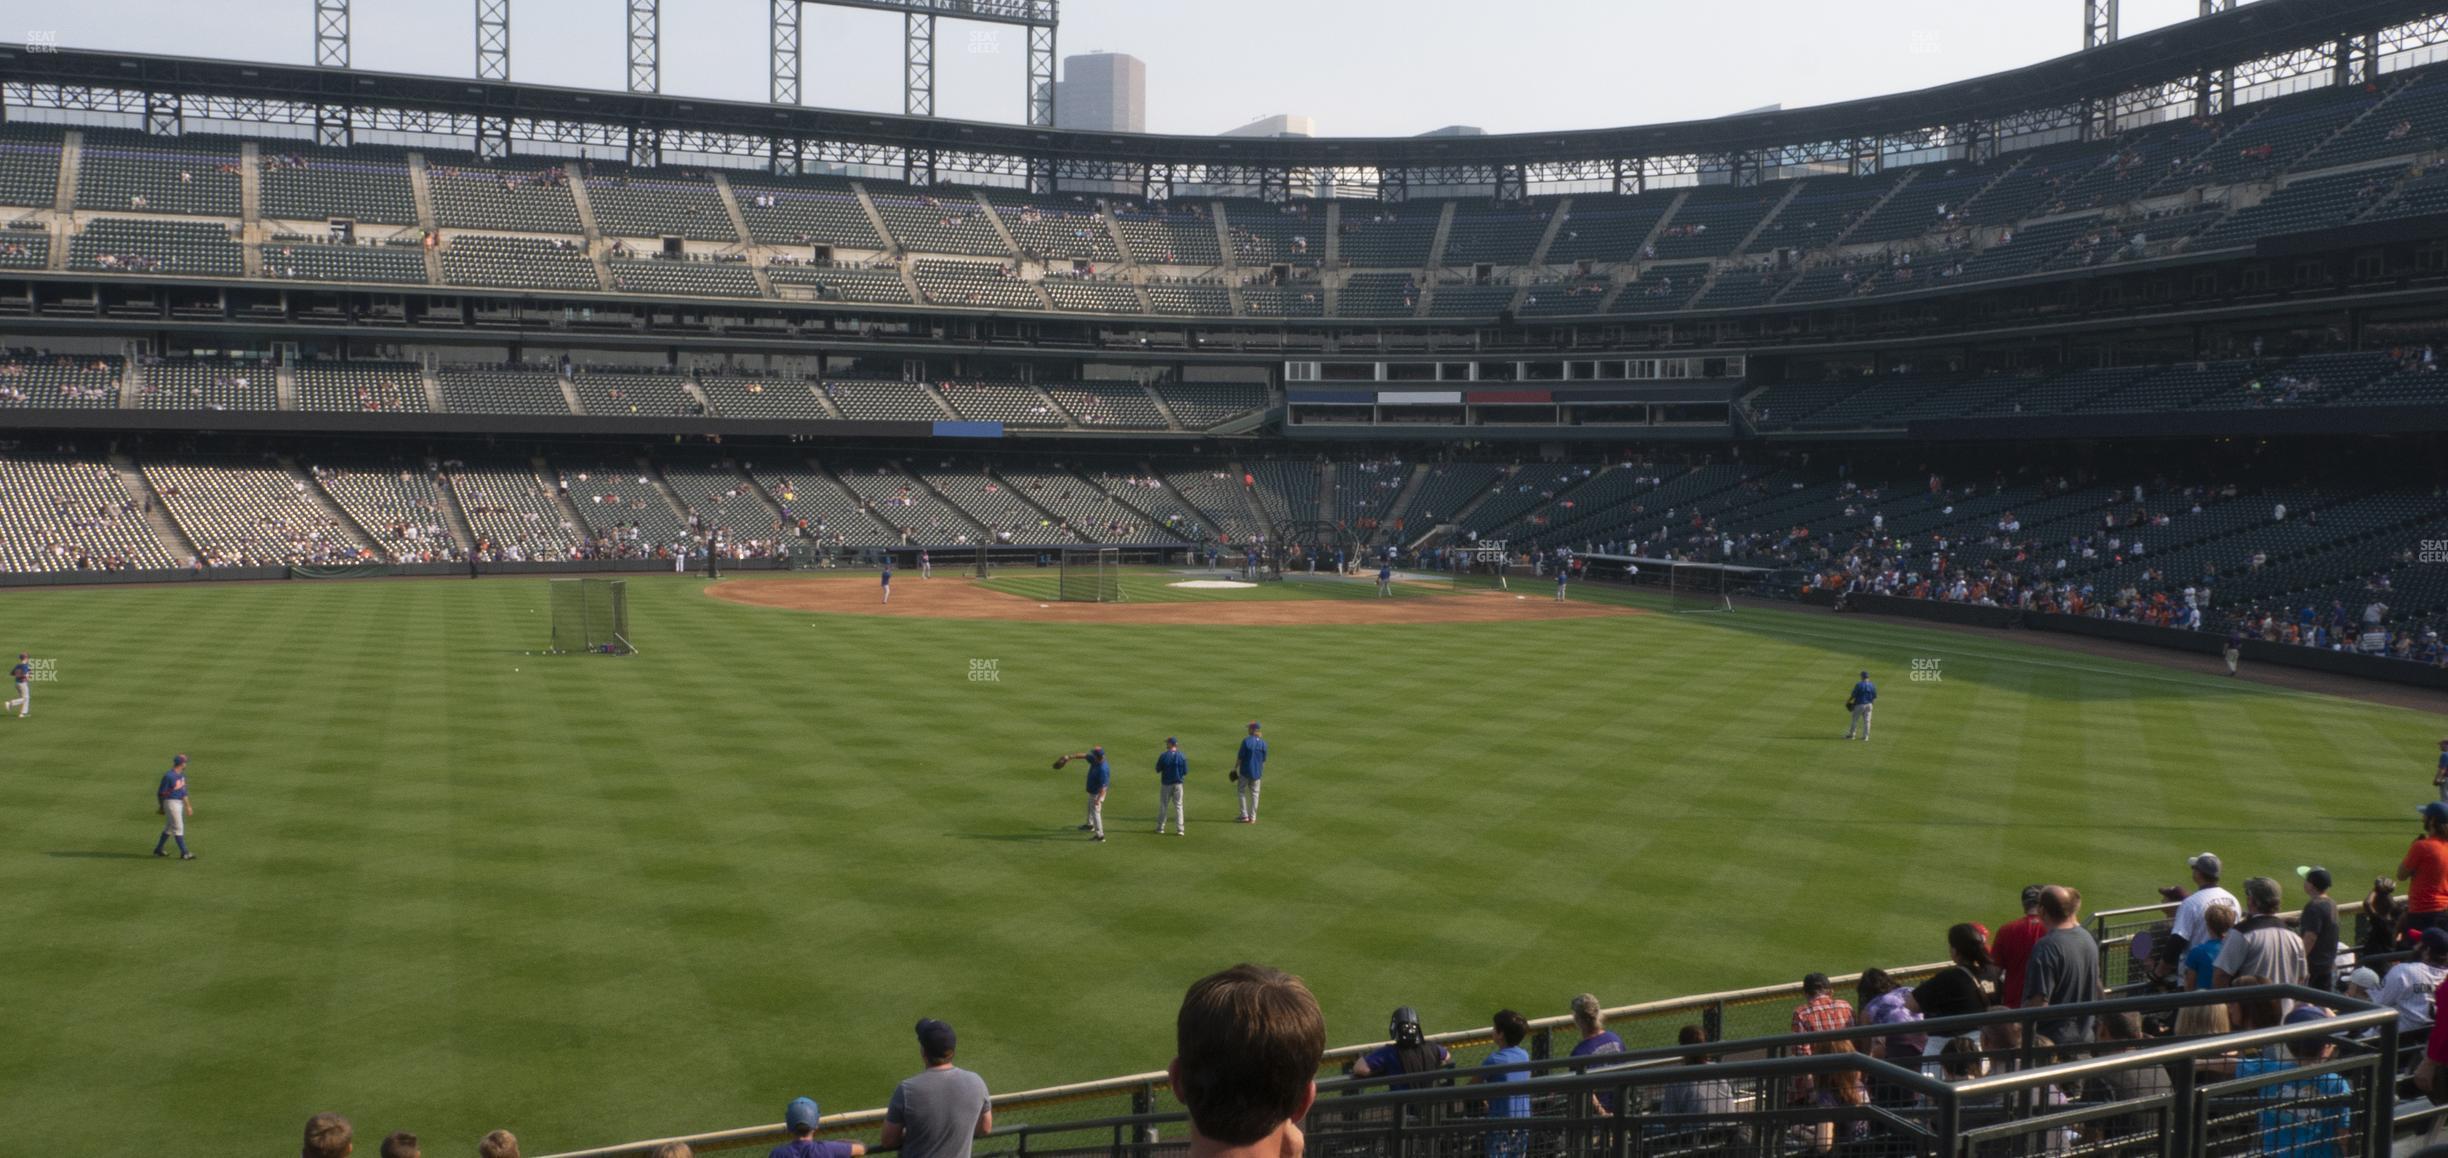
xmin=707 ymin=578 xmax=1643 ymax=627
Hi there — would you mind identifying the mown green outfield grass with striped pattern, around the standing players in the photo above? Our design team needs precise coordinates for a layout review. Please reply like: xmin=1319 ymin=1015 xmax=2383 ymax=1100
xmin=0 ymin=575 xmax=2441 ymax=1156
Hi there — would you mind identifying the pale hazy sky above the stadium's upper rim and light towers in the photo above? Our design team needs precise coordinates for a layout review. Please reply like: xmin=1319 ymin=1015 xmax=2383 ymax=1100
xmin=0 ymin=0 xmax=2242 ymax=137
